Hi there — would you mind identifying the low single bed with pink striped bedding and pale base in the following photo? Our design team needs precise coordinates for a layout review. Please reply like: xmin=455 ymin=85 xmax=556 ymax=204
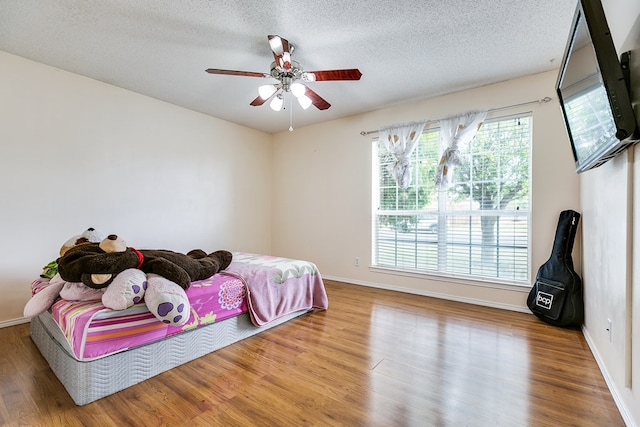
xmin=30 ymin=252 xmax=328 ymax=405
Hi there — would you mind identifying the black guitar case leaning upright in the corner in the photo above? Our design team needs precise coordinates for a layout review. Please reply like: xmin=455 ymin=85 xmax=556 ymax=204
xmin=527 ymin=210 xmax=584 ymax=326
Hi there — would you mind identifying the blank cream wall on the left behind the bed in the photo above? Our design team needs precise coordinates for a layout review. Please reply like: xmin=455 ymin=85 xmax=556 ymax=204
xmin=0 ymin=51 xmax=272 ymax=323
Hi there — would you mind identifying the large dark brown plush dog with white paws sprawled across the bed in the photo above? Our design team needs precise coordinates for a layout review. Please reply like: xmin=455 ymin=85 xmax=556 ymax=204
xmin=52 ymin=234 xmax=232 ymax=326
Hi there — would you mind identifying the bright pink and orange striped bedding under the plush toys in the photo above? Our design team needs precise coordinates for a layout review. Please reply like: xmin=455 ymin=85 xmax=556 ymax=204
xmin=51 ymin=271 xmax=247 ymax=361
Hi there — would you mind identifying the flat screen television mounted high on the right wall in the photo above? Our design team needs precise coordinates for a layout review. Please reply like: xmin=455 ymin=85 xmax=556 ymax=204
xmin=556 ymin=0 xmax=640 ymax=173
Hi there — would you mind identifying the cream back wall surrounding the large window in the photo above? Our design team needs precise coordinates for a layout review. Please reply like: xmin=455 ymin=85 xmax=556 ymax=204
xmin=272 ymin=72 xmax=580 ymax=312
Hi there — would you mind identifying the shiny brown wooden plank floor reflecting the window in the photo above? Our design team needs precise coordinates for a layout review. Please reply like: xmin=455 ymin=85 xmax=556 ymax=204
xmin=0 ymin=280 xmax=624 ymax=427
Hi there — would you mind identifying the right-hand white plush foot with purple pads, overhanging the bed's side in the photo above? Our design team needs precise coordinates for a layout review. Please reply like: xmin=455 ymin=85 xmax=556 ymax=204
xmin=144 ymin=274 xmax=191 ymax=326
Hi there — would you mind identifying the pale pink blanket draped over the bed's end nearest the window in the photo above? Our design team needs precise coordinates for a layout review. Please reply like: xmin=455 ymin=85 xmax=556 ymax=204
xmin=226 ymin=252 xmax=329 ymax=326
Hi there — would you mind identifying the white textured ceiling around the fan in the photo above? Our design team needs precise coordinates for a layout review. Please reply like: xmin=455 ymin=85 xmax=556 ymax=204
xmin=0 ymin=0 xmax=576 ymax=133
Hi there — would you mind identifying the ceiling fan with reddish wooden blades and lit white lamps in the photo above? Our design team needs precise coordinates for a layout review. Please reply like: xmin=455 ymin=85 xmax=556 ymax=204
xmin=206 ymin=35 xmax=362 ymax=111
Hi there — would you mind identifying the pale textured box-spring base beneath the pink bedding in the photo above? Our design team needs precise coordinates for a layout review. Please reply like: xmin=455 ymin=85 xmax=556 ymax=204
xmin=30 ymin=310 xmax=307 ymax=406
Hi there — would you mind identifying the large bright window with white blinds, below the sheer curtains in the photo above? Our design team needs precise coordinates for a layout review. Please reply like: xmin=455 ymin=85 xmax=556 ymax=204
xmin=373 ymin=115 xmax=531 ymax=284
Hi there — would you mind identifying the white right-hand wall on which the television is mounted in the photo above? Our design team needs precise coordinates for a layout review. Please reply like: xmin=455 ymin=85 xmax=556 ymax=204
xmin=580 ymin=0 xmax=640 ymax=425
